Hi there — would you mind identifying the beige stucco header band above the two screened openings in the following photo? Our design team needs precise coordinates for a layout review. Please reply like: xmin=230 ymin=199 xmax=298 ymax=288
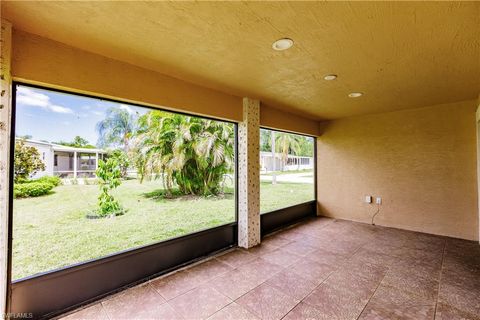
xmin=12 ymin=30 xmax=318 ymax=135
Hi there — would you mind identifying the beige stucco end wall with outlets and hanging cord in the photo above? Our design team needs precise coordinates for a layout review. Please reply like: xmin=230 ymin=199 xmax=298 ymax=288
xmin=318 ymin=101 xmax=478 ymax=240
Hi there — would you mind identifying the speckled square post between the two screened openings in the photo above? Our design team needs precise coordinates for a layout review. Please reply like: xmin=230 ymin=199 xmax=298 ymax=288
xmin=238 ymin=98 xmax=260 ymax=248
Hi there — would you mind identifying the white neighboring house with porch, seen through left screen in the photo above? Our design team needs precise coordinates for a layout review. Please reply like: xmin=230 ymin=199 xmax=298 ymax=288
xmin=15 ymin=138 xmax=107 ymax=179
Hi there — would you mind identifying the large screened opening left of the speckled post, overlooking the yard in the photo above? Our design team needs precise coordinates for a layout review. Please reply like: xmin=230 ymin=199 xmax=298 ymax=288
xmin=12 ymin=85 xmax=236 ymax=280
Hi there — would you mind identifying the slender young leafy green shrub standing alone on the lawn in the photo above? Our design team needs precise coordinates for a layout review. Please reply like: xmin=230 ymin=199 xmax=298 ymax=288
xmin=96 ymin=158 xmax=125 ymax=217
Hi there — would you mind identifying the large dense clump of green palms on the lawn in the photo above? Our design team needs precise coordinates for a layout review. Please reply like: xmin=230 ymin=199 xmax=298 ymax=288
xmin=135 ymin=111 xmax=234 ymax=195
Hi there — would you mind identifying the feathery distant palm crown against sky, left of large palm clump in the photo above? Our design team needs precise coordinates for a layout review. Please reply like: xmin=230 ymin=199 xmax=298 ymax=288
xmin=97 ymin=107 xmax=137 ymax=152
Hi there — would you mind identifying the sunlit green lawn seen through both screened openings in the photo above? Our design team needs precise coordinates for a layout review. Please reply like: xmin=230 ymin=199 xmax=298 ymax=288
xmin=12 ymin=180 xmax=313 ymax=279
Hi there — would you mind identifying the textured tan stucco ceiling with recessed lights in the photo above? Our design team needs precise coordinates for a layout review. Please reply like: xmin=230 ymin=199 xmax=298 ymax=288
xmin=2 ymin=1 xmax=480 ymax=119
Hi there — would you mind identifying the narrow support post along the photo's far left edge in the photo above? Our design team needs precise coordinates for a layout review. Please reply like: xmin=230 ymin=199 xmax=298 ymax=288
xmin=0 ymin=19 xmax=12 ymax=315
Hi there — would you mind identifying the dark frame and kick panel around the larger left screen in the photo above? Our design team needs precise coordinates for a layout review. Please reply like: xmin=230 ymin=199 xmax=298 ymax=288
xmin=7 ymin=81 xmax=238 ymax=318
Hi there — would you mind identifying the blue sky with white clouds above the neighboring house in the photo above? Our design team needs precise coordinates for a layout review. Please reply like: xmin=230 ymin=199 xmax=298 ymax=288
xmin=15 ymin=85 xmax=149 ymax=145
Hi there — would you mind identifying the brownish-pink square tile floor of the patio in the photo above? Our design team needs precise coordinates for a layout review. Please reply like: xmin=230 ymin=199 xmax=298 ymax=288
xmin=58 ymin=218 xmax=480 ymax=320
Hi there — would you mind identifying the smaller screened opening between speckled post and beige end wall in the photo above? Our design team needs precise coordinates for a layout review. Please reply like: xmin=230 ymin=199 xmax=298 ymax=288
xmin=260 ymin=129 xmax=315 ymax=213
